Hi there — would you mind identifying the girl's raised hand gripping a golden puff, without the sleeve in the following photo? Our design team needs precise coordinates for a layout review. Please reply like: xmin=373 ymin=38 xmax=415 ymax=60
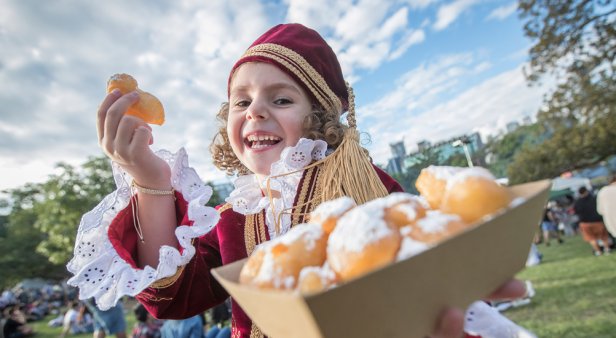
xmin=96 ymin=89 xmax=171 ymax=189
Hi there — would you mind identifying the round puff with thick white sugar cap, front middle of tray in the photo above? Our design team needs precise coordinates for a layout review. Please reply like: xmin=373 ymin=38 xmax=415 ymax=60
xmin=327 ymin=205 xmax=401 ymax=281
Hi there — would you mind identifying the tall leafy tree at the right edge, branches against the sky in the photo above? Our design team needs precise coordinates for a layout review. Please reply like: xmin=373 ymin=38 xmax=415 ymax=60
xmin=508 ymin=0 xmax=616 ymax=183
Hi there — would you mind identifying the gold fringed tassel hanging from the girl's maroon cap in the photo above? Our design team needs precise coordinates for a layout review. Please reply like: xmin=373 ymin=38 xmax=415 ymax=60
xmin=321 ymin=83 xmax=388 ymax=204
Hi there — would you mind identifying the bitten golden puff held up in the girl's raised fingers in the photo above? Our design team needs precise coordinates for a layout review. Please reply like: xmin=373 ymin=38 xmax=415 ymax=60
xmin=107 ymin=74 xmax=165 ymax=125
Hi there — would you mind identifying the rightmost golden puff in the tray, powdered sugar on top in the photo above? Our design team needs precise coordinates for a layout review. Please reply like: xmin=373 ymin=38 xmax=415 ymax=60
xmin=441 ymin=167 xmax=513 ymax=223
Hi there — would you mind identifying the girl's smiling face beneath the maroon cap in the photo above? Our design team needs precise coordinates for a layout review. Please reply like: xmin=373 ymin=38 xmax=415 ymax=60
xmin=227 ymin=62 xmax=312 ymax=176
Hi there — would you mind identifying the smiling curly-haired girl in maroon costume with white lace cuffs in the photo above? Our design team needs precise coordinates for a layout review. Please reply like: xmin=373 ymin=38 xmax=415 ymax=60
xmin=68 ymin=24 xmax=523 ymax=337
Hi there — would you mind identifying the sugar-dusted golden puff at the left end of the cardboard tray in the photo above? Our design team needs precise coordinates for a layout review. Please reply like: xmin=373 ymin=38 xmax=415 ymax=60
xmin=239 ymin=224 xmax=327 ymax=289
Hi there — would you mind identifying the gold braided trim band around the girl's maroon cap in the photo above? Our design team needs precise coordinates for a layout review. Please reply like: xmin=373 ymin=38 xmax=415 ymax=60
xmin=242 ymin=43 xmax=342 ymax=112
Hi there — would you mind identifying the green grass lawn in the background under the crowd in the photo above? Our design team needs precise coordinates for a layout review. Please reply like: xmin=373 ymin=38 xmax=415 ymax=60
xmin=26 ymin=237 xmax=616 ymax=338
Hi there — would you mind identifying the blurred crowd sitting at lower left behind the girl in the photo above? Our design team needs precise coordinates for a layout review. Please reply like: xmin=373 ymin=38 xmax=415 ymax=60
xmin=0 ymin=284 xmax=231 ymax=338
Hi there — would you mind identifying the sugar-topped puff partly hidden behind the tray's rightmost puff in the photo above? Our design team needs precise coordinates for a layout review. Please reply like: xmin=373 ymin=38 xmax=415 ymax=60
xmin=415 ymin=165 xmax=463 ymax=209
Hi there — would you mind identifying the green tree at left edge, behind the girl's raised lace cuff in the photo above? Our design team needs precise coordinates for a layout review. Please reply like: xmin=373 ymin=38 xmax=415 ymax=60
xmin=0 ymin=157 xmax=114 ymax=286
